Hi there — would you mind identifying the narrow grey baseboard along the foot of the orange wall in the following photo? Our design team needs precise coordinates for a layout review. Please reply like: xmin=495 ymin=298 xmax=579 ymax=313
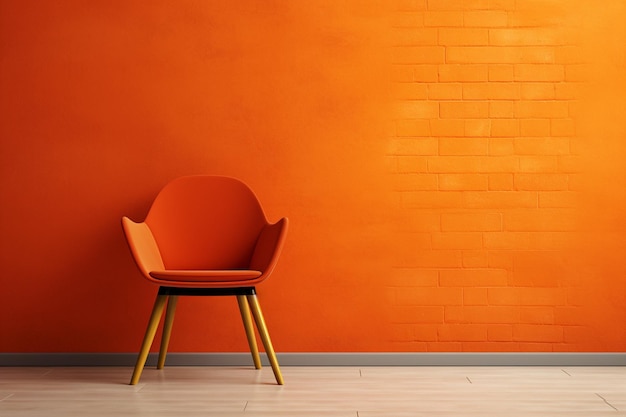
xmin=0 ymin=352 xmax=626 ymax=366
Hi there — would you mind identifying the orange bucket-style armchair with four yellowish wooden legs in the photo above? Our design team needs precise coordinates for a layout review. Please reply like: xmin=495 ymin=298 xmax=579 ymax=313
xmin=122 ymin=175 xmax=288 ymax=385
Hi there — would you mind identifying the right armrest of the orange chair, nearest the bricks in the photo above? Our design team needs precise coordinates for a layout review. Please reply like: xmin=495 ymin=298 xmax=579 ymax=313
xmin=250 ymin=217 xmax=289 ymax=275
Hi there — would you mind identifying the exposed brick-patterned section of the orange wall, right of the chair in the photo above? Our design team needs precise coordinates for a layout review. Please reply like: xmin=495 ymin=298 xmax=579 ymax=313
xmin=388 ymin=0 xmax=584 ymax=351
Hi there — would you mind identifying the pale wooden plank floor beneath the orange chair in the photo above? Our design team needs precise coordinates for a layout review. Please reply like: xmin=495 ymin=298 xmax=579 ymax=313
xmin=0 ymin=366 xmax=626 ymax=417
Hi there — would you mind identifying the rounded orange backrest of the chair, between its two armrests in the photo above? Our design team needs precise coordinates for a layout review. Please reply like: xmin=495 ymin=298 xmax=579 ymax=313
xmin=145 ymin=175 xmax=267 ymax=269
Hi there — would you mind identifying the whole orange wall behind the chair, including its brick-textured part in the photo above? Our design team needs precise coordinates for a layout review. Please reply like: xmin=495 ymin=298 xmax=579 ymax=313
xmin=0 ymin=0 xmax=626 ymax=352
